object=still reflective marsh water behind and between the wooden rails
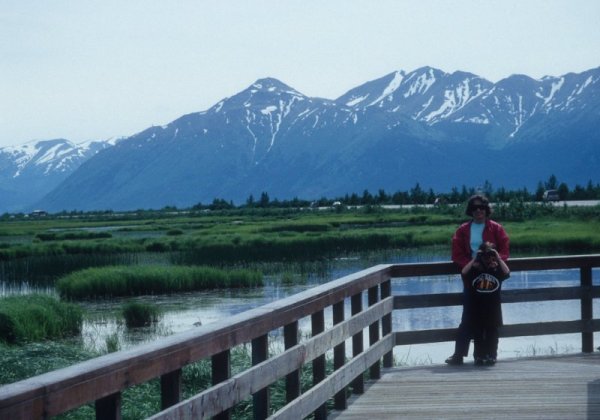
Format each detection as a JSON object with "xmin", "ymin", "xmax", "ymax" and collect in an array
[{"xmin": 0, "ymin": 249, "xmax": 600, "ymax": 365}]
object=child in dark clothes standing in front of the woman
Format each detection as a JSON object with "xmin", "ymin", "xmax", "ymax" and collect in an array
[{"xmin": 461, "ymin": 242, "xmax": 510, "ymax": 365}]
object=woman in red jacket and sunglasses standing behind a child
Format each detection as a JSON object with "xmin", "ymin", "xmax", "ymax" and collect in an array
[{"xmin": 446, "ymin": 194, "xmax": 509, "ymax": 365}]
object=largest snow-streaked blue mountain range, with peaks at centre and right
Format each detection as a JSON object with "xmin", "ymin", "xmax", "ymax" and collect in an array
[{"xmin": 2, "ymin": 67, "xmax": 600, "ymax": 211}]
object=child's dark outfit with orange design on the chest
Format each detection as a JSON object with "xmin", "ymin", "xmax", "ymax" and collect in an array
[{"xmin": 463, "ymin": 266, "xmax": 509, "ymax": 360}]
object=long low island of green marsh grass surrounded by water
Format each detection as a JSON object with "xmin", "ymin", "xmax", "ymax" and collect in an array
[{"xmin": 56, "ymin": 265, "xmax": 263, "ymax": 299}]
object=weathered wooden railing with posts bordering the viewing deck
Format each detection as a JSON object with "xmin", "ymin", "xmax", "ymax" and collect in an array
[{"xmin": 0, "ymin": 255, "xmax": 600, "ymax": 419}]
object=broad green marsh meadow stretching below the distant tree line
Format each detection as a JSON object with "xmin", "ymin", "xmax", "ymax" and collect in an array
[{"xmin": 0, "ymin": 205, "xmax": 600, "ymax": 282}]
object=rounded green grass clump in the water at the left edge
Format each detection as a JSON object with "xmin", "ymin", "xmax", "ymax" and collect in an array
[{"xmin": 0, "ymin": 294, "xmax": 83, "ymax": 344}]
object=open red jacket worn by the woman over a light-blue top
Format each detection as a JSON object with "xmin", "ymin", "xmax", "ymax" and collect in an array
[{"xmin": 452, "ymin": 219, "xmax": 509, "ymax": 270}]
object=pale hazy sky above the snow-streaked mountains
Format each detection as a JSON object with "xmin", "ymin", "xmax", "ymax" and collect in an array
[{"xmin": 0, "ymin": 0, "xmax": 600, "ymax": 147}]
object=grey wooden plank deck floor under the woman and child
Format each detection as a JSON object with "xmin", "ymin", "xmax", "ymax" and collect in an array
[{"xmin": 330, "ymin": 352, "xmax": 600, "ymax": 420}]
